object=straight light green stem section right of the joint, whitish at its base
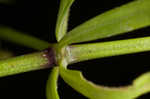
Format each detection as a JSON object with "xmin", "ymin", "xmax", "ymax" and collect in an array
[{"xmin": 66, "ymin": 37, "xmax": 150, "ymax": 63}]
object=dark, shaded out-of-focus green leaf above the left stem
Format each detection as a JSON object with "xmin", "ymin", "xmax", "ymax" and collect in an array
[{"xmin": 0, "ymin": 27, "xmax": 51, "ymax": 50}]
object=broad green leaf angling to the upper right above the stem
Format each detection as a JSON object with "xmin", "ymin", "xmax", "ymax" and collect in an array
[{"xmin": 60, "ymin": 0, "xmax": 150, "ymax": 46}]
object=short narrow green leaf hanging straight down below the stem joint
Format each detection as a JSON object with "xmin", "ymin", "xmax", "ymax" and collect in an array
[{"xmin": 46, "ymin": 67, "xmax": 59, "ymax": 99}]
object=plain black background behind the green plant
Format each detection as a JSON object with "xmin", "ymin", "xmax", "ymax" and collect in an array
[{"xmin": 0, "ymin": 0, "xmax": 150, "ymax": 99}]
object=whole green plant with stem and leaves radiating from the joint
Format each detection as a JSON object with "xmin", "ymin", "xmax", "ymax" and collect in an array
[{"xmin": 0, "ymin": 0, "xmax": 150, "ymax": 99}]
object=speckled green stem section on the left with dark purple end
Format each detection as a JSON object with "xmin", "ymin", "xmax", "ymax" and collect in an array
[{"xmin": 0, "ymin": 49, "xmax": 55, "ymax": 77}]
